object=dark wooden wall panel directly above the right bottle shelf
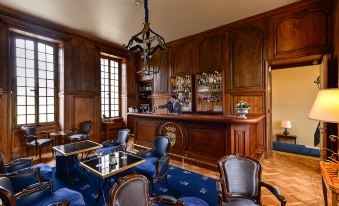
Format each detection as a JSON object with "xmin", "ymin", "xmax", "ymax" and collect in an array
[{"xmin": 196, "ymin": 32, "xmax": 225, "ymax": 72}]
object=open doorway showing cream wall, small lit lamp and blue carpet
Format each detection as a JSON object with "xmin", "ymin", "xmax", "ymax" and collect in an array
[{"xmin": 271, "ymin": 64, "xmax": 322, "ymax": 157}]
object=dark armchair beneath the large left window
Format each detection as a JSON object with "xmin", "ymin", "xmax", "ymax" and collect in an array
[{"xmin": 21, "ymin": 126, "xmax": 54, "ymax": 162}]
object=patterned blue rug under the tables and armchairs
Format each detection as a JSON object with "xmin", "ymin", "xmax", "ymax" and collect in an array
[{"xmin": 53, "ymin": 166, "xmax": 218, "ymax": 206}]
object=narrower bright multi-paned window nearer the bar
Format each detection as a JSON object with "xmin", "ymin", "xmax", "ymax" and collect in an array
[{"xmin": 101, "ymin": 57, "xmax": 120, "ymax": 117}]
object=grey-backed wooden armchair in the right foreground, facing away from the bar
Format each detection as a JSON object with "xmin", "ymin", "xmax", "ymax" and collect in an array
[{"xmin": 217, "ymin": 155, "xmax": 286, "ymax": 206}]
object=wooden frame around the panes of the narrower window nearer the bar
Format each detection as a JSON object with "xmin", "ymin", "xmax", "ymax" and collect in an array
[{"xmin": 99, "ymin": 54, "xmax": 122, "ymax": 119}]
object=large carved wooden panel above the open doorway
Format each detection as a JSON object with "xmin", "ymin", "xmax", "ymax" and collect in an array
[{"xmin": 270, "ymin": 1, "xmax": 332, "ymax": 60}]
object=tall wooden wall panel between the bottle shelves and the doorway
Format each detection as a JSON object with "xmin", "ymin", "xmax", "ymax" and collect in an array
[{"xmin": 226, "ymin": 23, "xmax": 267, "ymax": 90}]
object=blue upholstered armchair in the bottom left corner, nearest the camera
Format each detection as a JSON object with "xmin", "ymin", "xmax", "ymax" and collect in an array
[{"xmin": 0, "ymin": 177, "xmax": 86, "ymax": 206}]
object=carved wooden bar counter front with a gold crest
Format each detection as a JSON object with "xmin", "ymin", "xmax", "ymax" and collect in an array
[{"xmin": 127, "ymin": 113, "xmax": 266, "ymax": 166}]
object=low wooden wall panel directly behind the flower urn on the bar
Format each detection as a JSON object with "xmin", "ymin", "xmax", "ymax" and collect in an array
[{"xmin": 231, "ymin": 93, "xmax": 265, "ymax": 114}]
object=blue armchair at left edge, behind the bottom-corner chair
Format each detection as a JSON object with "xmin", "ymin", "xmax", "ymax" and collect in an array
[{"xmin": 0, "ymin": 152, "xmax": 53, "ymax": 181}]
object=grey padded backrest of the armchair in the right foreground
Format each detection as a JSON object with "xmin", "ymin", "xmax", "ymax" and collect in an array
[{"xmin": 219, "ymin": 155, "xmax": 261, "ymax": 204}]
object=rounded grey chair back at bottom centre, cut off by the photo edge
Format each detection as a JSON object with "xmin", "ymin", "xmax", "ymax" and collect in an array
[{"xmin": 108, "ymin": 174, "xmax": 150, "ymax": 206}]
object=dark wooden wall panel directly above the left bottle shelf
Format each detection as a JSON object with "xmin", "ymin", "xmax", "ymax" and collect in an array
[{"xmin": 171, "ymin": 41, "xmax": 195, "ymax": 75}]
